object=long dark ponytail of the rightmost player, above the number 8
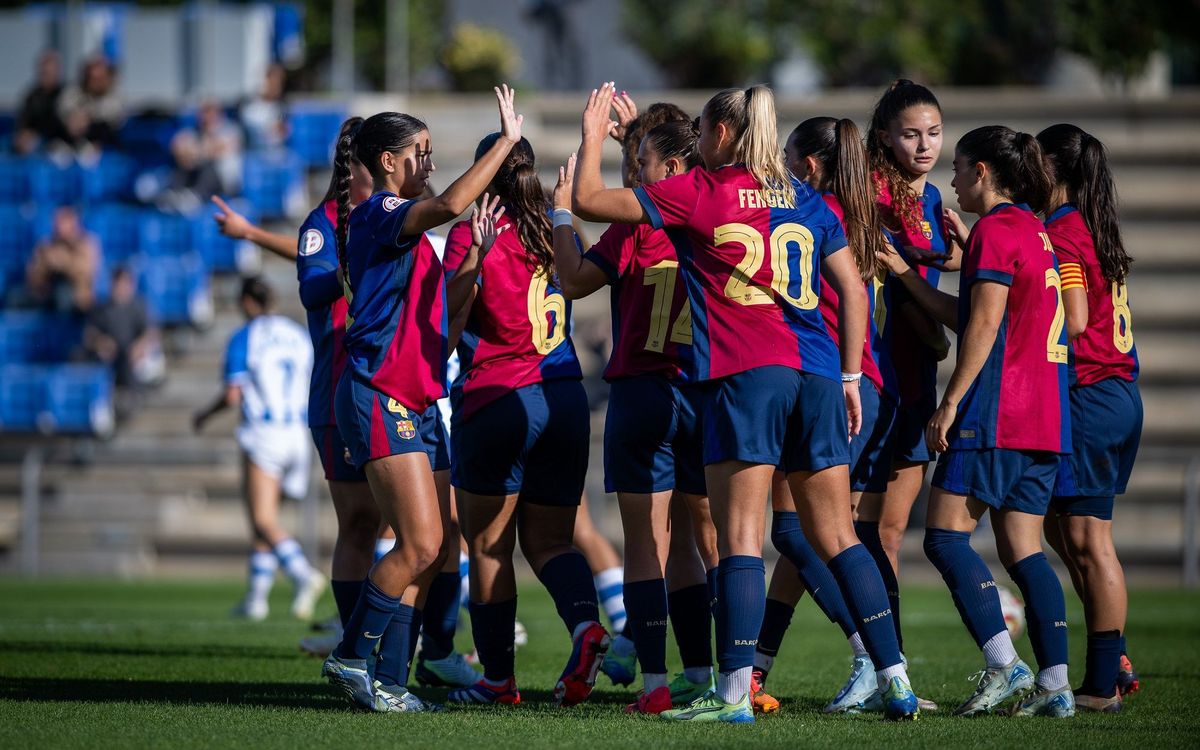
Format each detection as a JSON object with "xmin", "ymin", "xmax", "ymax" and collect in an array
[{"xmin": 1038, "ymin": 124, "xmax": 1133, "ymax": 283}]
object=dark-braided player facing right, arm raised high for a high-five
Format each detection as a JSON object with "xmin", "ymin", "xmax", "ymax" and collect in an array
[{"xmin": 323, "ymin": 85, "xmax": 523, "ymax": 712}]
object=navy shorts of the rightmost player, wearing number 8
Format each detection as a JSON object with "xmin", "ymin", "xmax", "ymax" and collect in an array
[{"xmin": 1054, "ymin": 378, "xmax": 1142, "ymax": 521}]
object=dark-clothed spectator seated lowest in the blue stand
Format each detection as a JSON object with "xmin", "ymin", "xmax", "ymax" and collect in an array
[{"xmin": 83, "ymin": 266, "xmax": 164, "ymax": 416}]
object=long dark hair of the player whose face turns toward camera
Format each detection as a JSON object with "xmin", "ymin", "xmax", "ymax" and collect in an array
[{"xmin": 866, "ymin": 78, "xmax": 942, "ymax": 230}]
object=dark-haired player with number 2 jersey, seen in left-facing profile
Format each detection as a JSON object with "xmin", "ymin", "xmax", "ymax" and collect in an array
[{"xmin": 884, "ymin": 125, "xmax": 1075, "ymax": 716}]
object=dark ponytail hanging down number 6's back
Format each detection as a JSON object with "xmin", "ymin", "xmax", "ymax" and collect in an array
[{"xmin": 475, "ymin": 133, "xmax": 554, "ymax": 278}]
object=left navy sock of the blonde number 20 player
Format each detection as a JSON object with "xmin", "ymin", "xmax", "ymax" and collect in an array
[{"xmin": 716, "ymin": 554, "xmax": 767, "ymax": 673}]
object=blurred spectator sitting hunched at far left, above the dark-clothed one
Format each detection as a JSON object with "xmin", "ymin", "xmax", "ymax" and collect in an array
[{"xmin": 25, "ymin": 205, "xmax": 101, "ymax": 313}]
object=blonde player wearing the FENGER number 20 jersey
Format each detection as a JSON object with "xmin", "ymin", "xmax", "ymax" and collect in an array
[{"xmin": 574, "ymin": 84, "xmax": 917, "ymax": 722}]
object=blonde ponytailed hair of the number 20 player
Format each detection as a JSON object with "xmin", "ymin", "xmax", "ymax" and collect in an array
[{"xmin": 703, "ymin": 85, "xmax": 796, "ymax": 208}]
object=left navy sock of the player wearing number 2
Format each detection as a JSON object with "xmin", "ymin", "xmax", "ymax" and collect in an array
[{"xmin": 924, "ymin": 528, "xmax": 1006, "ymax": 648}]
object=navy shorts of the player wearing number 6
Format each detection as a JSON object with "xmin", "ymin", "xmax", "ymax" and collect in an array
[{"xmin": 450, "ymin": 380, "xmax": 590, "ymax": 506}]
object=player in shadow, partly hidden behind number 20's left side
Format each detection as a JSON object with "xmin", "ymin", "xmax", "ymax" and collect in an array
[{"xmin": 554, "ymin": 120, "xmax": 712, "ymax": 714}]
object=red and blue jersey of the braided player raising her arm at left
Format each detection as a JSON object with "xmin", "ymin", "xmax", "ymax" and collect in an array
[{"xmin": 344, "ymin": 192, "xmax": 449, "ymax": 412}]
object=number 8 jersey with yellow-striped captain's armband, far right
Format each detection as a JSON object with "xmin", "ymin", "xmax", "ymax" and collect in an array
[{"xmin": 1046, "ymin": 203, "xmax": 1138, "ymax": 385}]
